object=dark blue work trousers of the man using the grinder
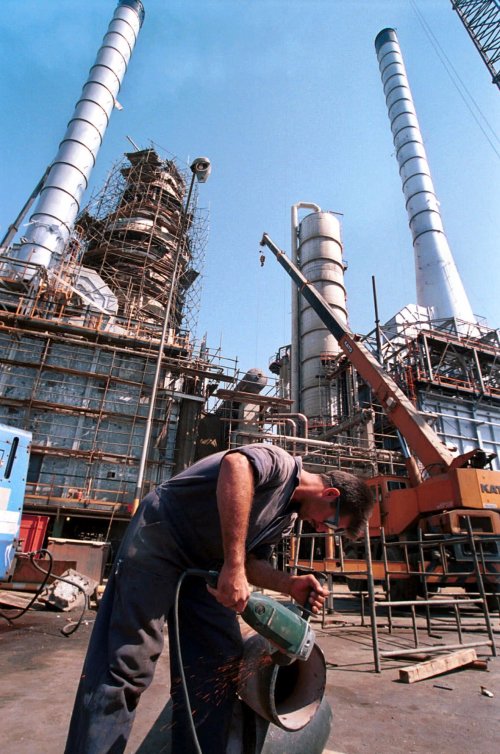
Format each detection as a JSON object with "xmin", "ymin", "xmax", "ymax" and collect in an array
[{"xmin": 65, "ymin": 493, "xmax": 242, "ymax": 754}]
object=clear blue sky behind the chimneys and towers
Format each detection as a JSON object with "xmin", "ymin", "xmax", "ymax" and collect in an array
[{"xmin": 0, "ymin": 0, "xmax": 500, "ymax": 376}]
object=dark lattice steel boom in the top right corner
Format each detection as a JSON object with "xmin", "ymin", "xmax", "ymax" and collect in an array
[{"xmin": 451, "ymin": 0, "xmax": 500, "ymax": 88}]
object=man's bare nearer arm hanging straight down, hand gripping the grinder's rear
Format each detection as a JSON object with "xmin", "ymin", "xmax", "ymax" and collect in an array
[{"xmin": 208, "ymin": 452, "xmax": 254, "ymax": 612}]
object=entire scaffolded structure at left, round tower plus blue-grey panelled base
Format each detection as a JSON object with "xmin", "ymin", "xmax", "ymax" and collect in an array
[{"xmin": 0, "ymin": 149, "xmax": 236, "ymax": 536}]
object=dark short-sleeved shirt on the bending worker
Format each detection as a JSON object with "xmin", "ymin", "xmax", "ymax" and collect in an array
[{"xmin": 157, "ymin": 444, "xmax": 302, "ymax": 567}]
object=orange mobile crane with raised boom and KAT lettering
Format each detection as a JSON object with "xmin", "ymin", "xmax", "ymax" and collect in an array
[{"xmin": 260, "ymin": 233, "xmax": 500, "ymax": 593}]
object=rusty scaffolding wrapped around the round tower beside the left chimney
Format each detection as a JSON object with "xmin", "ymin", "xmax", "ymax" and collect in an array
[{"xmin": 78, "ymin": 149, "xmax": 207, "ymax": 332}]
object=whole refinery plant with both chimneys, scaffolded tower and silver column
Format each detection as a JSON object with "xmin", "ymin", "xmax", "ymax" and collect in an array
[{"xmin": 0, "ymin": 0, "xmax": 500, "ymax": 568}]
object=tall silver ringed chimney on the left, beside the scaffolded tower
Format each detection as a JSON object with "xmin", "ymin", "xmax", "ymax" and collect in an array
[{"xmin": 12, "ymin": 0, "xmax": 144, "ymax": 280}]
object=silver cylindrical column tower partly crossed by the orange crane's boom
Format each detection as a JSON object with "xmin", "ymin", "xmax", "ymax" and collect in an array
[{"xmin": 292, "ymin": 209, "xmax": 347, "ymax": 423}]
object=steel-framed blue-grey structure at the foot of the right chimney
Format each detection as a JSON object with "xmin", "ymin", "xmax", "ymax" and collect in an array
[{"xmin": 376, "ymin": 320, "xmax": 500, "ymax": 469}]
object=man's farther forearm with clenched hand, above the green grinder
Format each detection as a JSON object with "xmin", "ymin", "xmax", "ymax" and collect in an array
[{"xmin": 246, "ymin": 555, "xmax": 327, "ymax": 613}]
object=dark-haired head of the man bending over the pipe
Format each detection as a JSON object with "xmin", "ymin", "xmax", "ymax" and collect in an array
[{"xmin": 320, "ymin": 471, "xmax": 373, "ymax": 539}]
